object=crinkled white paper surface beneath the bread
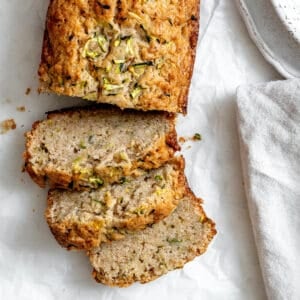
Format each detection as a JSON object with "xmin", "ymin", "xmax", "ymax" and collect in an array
[{"xmin": 0, "ymin": 0, "xmax": 280, "ymax": 300}]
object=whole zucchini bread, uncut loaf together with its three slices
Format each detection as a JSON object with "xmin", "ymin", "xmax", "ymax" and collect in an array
[{"xmin": 24, "ymin": 0, "xmax": 216, "ymax": 286}]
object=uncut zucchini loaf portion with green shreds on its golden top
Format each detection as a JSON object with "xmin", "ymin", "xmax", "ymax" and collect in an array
[{"xmin": 39, "ymin": 0, "xmax": 199, "ymax": 112}]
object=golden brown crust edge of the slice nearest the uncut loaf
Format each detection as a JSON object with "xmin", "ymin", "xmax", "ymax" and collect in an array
[{"xmin": 23, "ymin": 105, "xmax": 180, "ymax": 190}]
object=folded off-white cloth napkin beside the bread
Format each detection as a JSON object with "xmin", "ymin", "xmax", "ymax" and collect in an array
[{"xmin": 237, "ymin": 79, "xmax": 300, "ymax": 300}]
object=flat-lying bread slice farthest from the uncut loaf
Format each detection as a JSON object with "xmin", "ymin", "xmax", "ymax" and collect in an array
[{"xmin": 89, "ymin": 193, "xmax": 216, "ymax": 287}]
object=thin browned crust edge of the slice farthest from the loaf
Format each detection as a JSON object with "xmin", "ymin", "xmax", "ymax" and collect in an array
[{"xmin": 92, "ymin": 187, "xmax": 217, "ymax": 287}]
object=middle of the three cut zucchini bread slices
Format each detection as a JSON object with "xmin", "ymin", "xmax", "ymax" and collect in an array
[{"xmin": 45, "ymin": 157, "xmax": 186, "ymax": 249}]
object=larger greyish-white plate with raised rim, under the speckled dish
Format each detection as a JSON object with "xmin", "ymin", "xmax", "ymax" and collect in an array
[{"xmin": 236, "ymin": 0, "xmax": 300, "ymax": 78}]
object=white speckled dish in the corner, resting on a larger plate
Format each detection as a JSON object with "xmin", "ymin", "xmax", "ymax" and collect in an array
[{"xmin": 271, "ymin": 0, "xmax": 300, "ymax": 43}]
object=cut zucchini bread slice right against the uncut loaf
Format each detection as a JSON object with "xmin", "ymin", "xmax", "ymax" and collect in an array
[{"xmin": 24, "ymin": 107, "xmax": 179, "ymax": 190}]
